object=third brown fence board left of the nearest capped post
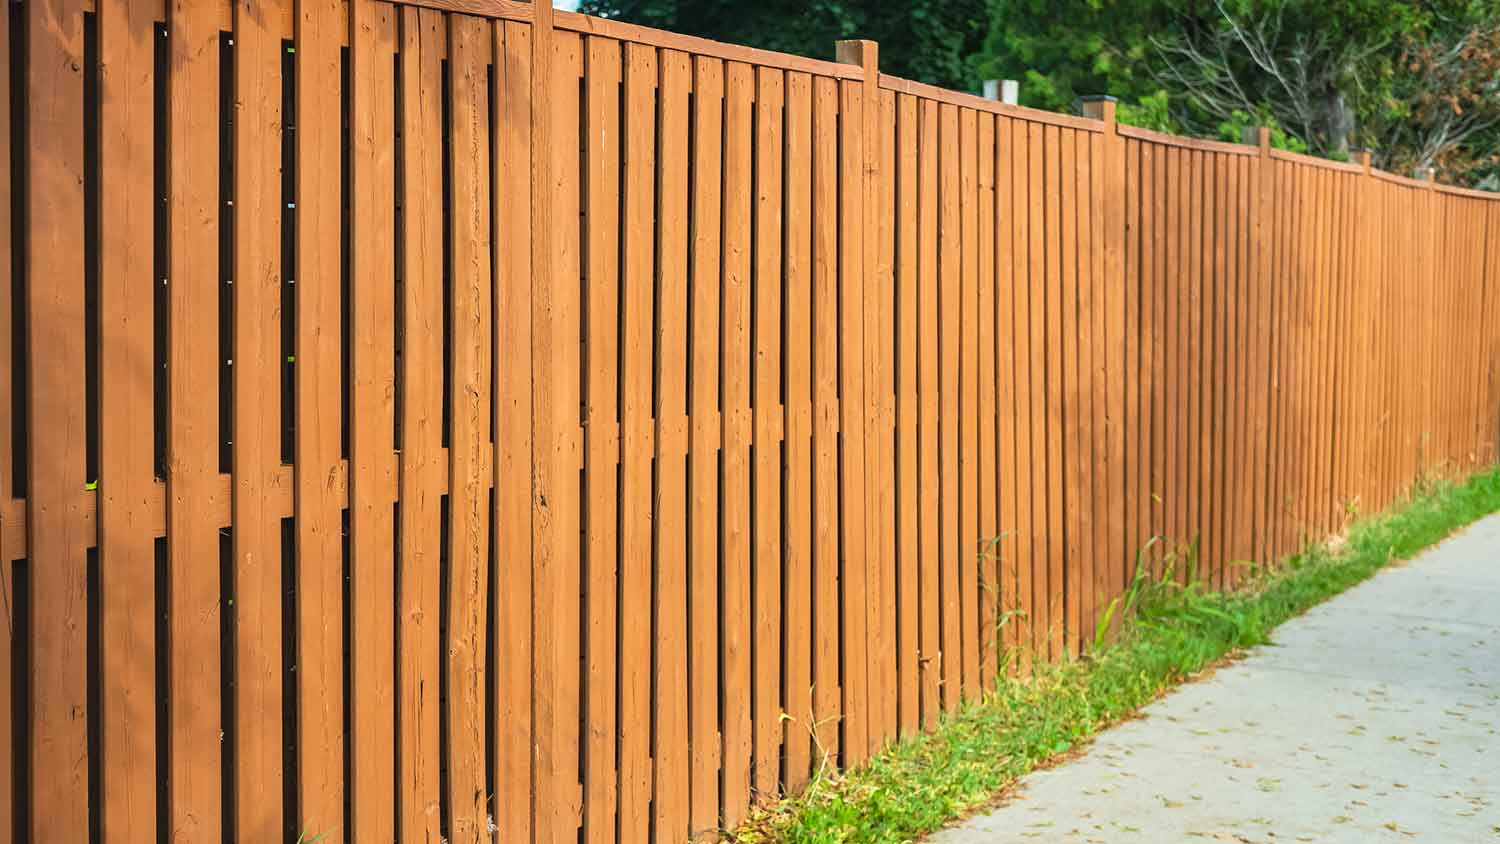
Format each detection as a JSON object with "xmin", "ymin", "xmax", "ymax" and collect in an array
[{"xmin": 750, "ymin": 67, "xmax": 786, "ymax": 796}]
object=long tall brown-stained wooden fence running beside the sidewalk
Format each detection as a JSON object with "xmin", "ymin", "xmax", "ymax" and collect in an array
[{"xmin": 0, "ymin": 0, "xmax": 1500, "ymax": 844}]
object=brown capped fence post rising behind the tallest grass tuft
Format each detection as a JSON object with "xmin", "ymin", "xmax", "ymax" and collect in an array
[{"xmin": 1083, "ymin": 96, "xmax": 1139, "ymax": 636}]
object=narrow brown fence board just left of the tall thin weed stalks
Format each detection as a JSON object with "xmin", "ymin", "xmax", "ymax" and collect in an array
[{"xmin": 954, "ymin": 109, "xmax": 983, "ymax": 686}]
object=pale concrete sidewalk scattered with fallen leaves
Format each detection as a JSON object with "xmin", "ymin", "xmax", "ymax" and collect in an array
[{"xmin": 932, "ymin": 516, "xmax": 1500, "ymax": 844}]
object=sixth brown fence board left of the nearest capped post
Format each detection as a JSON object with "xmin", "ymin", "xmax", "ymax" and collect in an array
[{"xmin": 653, "ymin": 51, "xmax": 692, "ymax": 840}]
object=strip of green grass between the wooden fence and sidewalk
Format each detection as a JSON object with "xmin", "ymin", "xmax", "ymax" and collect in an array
[{"xmin": 731, "ymin": 469, "xmax": 1500, "ymax": 844}]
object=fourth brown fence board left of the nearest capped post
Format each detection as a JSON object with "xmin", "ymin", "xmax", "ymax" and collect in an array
[{"xmin": 719, "ymin": 63, "xmax": 755, "ymax": 829}]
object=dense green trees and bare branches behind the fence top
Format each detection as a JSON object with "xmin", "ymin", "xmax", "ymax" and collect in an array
[{"xmin": 582, "ymin": 0, "xmax": 1500, "ymax": 189}]
